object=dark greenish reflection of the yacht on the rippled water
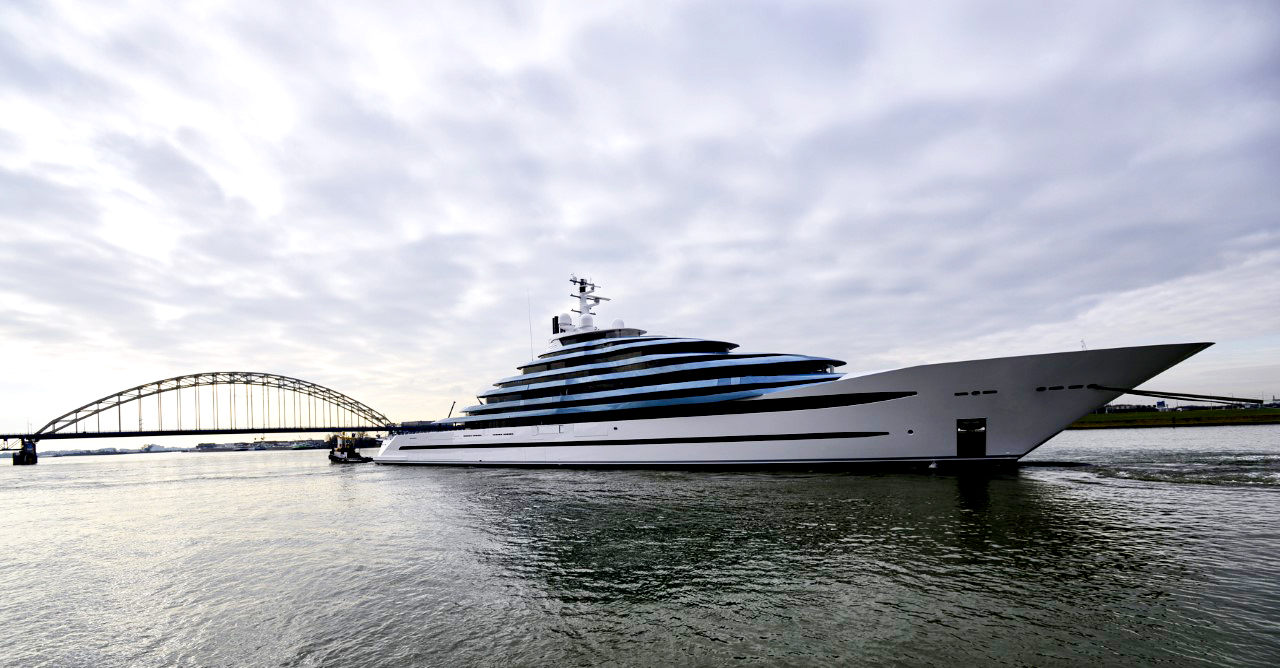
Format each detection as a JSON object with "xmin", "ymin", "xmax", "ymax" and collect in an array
[{"xmin": 391, "ymin": 470, "xmax": 1249, "ymax": 664}]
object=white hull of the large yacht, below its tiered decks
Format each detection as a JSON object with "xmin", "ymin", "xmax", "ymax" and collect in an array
[{"xmin": 374, "ymin": 343, "xmax": 1210, "ymax": 467}]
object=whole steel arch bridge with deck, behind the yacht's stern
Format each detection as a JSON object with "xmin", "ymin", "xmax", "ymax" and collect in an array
[{"xmin": 0, "ymin": 371, "xmax": 396, "ymax": 449}]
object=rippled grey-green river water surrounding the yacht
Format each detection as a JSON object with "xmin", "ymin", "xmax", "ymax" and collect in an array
[{"xmin": 0, "ymin": 426, "xmax": 1280, "ymax": 667}]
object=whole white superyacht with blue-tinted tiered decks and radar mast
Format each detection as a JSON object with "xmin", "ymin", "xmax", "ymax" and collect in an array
[{"xmin": 374, "ymin": 276, "xmax": 1211, "ymax": 467}]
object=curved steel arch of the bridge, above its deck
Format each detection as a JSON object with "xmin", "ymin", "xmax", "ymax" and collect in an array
[{"xmin": 32, "ymin": 371, "xmax": 392, "ymax": 438}]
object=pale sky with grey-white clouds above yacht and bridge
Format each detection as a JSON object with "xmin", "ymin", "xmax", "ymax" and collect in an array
[{"xmin": 0, "ymin": 0, "xmax": 1280, "ymax": 442}]
